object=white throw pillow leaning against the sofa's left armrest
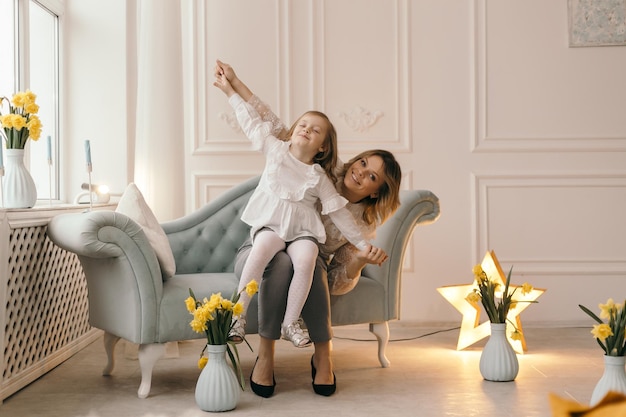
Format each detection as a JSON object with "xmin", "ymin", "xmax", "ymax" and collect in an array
[{"xmin": 115, "ymin": 183, "xmax": 176, "ymax": 279}]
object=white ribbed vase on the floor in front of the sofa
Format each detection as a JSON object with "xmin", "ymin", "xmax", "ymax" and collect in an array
[{"xmin": 196, "ymin": 345, "xmax": 241, "ymax": 411}]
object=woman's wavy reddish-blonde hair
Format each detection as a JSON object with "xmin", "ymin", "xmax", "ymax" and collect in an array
[{"xmin": 341, "ymin": 149, "xmax": 402, "ymax": 224}]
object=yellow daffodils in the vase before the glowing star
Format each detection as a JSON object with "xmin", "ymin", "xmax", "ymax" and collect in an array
[{"xmin": 466, "ymin": 265, "xmax": 536, "ymax": 340}]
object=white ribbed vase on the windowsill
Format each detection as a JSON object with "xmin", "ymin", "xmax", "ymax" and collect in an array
[{"xmin": 0, "ymin": 149, "xmax": 37, "ymax": 208}]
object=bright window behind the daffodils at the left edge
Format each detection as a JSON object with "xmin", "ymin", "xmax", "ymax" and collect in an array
[{"xmin": 0, "ymin": 0, "xmax": 60, "ymax": 200}]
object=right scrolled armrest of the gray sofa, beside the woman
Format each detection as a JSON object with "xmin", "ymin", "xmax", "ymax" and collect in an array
[{"xmin": 362, "ymin": 190, "xmax": 440, "ymax": 319}]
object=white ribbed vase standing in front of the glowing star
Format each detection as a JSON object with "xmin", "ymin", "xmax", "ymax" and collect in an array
[{"xmin": 479, "ymin": 323, "xmax": 519, "ymax": 382}]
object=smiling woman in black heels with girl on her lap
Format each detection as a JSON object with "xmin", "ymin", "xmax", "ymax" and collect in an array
[{"xmin": 215, "ymin": 61, "xmax": 401, "ymax": 398}]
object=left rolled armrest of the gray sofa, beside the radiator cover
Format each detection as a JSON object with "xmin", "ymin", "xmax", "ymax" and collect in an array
[{"xmin": 47, "ymin": 210, "xmax": 163, "ymax": 343}]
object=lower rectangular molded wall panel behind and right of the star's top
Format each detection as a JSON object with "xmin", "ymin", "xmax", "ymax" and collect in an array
[{"xmin": 472, "ymin": 172, "xmax": 626, "ymax": 276}]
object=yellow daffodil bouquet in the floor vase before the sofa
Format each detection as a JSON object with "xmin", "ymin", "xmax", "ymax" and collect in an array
[{"xmin": 185, "ymin": 280, "xmax": 259, "ymax": 389}]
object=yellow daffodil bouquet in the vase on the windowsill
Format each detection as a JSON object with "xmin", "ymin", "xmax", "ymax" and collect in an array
[{"xmin": 0, "ymin": 90, "xmax": 41, "ymax": 149}]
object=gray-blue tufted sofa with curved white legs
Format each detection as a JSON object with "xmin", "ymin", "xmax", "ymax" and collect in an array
[{"xmin": 48, "ymin": 177, "xmax": 439, "ymax": 398}]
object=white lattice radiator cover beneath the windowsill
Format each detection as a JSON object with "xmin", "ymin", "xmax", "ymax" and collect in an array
[{"xmin": 0, "ymin": 206, "xmax": 112, "ymax": 402}]
